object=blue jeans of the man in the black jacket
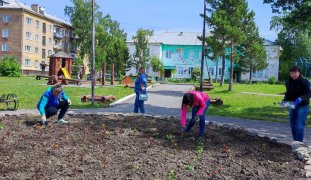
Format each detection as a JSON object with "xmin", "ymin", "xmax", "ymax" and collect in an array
[{"xmin": 288, "ymin": 105, "xmax": 309, "ymax": 142}]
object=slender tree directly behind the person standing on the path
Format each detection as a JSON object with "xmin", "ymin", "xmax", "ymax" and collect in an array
[{"xmin": 128, "ymin": 29, "xmax": 153, "ymax": 68}]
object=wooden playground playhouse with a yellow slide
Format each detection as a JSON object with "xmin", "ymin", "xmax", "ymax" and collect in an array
[{"xmin": 36, "ymin": 52, "xmax": 83, "ymax": 85}]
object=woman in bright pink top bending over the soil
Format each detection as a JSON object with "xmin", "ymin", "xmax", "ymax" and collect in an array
[{"xmin": 180, "ymin": 91, "xmax": 210, "ymax": 137}]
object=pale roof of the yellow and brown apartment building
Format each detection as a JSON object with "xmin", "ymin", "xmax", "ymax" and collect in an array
[{"xmin": 0, "ymin": 0, "xmax": 71, "ymax": 26}]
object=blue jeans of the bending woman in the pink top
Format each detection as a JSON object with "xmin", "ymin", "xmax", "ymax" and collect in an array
[{"xmin": 185, "ymin": 100, "xmax": 210, "ymax": 137}]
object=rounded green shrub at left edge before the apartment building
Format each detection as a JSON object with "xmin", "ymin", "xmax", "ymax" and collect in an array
[{"xmin": 0, "ymin": 56, "xmax": 21, "ymax": 77}]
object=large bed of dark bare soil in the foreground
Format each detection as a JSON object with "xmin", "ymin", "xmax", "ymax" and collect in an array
[{"xmin": 0, "ymin": 114, "xmax": 305, "ymax": 180}]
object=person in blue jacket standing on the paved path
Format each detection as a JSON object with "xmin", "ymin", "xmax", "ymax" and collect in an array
[{"xmin": 134, "ymin": 67, "xmax": 147, "ymax": 113}]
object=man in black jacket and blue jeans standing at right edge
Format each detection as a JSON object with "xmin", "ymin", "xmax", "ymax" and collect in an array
[{"xmin": 283, "ymin": 66, "xmax": 311, "ymax": 142}]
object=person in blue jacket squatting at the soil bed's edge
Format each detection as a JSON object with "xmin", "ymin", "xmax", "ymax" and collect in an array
[{"xmin": 37, "ymin": 83, "xmax": 71, "ymax": 125}]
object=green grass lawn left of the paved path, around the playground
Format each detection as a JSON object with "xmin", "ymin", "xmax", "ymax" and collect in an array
[{"xmin": 0, "ymin": 76, "xmax": 133, "ymax": 109}]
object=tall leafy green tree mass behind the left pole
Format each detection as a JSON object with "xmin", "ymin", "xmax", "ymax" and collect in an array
[{"xmin": 65, "ymin": 0, "xmax": 129, "ymax": 74}]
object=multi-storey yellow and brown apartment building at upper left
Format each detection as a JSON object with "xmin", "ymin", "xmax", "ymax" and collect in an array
[{"xmin": 0, "ymin": 0, "xmax": 74, "ymax": 74}]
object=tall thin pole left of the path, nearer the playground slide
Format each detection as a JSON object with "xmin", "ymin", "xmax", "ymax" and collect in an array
[{"xmin": 91, "ymin": 0, "xmax": 96, "ymax": 104}]
